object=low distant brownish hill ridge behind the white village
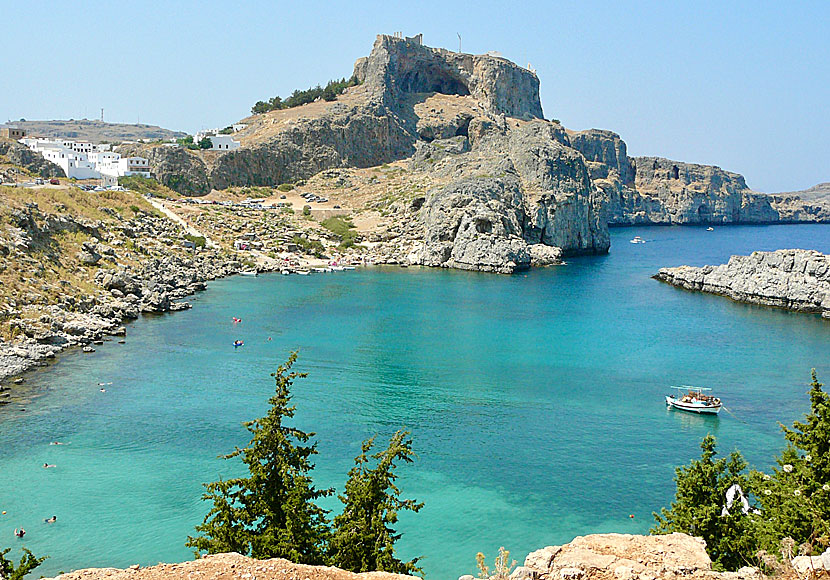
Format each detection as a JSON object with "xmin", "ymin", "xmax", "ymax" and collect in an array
[{"xmin": 4, "ymin": 119, "xmax": 187, "ymax": 143}]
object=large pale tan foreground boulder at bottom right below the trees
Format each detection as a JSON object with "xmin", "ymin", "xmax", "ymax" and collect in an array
[{"xmin": 510, "ymin": 533, "xmax": 760, "ymax": 580}]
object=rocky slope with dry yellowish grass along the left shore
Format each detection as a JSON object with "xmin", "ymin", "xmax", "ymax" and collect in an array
[{"xmin": 0, "ymin": 198, "xmax": 254, "ymax": 390}]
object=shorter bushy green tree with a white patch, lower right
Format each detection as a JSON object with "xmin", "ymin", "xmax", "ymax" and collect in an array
[{"xmin": 651, "ymin": 435, "xmax": 757, "ymax": 570}]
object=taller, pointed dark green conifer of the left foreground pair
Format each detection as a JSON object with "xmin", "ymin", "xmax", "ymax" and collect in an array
[{"xmin": 187, "ymin": 352, "xmax": 333, "ymax": 564}]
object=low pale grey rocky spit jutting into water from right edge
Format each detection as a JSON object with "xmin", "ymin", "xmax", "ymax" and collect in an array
[{"xmin": 654, "ymin": 250, "xmax": 830, "ymax": 319}]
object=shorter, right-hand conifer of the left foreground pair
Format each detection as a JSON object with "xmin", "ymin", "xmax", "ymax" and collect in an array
[{"xmin": 330, "ymin": 431, "xmax": 424, "ymax": 574}]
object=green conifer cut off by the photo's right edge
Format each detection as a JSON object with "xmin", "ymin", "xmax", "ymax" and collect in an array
[{"xmin": 752, "ymin": 369, "xmax": 830, "ymax": 552}]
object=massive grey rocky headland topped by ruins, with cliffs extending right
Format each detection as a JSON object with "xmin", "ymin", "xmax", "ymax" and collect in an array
[{"xmin": 75, "ymin": 35, "xmax": 830, "ymax": 272}]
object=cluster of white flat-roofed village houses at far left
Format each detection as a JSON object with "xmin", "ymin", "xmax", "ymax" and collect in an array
[{"xmin": 20, "ymin": 137, "xmax": 150, "ymax": 185}]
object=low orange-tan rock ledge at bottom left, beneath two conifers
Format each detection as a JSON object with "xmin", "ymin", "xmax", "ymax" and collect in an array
[{"xmin": 44, "ymin": 553, "xmax": 414, "ymax": 580}]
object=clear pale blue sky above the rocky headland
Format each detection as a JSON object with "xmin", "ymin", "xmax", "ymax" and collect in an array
[{"xmin": 0, "ymin": 0, "xmax": 830, "ymax": 192}]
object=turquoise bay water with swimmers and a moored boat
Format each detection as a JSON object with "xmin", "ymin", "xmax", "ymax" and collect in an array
[{"xmin": 0, "ymin": 226, "xmax": 830, "ymax": 578}]
